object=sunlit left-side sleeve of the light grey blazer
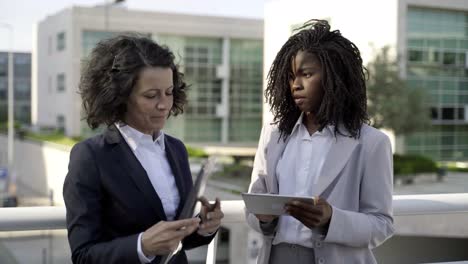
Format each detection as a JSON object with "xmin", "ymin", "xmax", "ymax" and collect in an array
[{"xmin": 244, "ymin": 125, "xmax": 278, "ymax": 236}]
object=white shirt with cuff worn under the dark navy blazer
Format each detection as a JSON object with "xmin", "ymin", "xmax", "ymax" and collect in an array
[{"xmin": 116, "ymin": 124, "xmax": 180, "ymax": 263}]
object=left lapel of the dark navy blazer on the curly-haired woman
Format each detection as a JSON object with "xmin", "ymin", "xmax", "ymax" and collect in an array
[{"xmin": 105, "ymin": 126, "xmax": 167, "ymax": 220}]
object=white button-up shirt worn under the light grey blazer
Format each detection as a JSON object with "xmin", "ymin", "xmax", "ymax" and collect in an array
[{"xmin": 273, "ymin": 113, "xmax": 334, "ymax": 248}]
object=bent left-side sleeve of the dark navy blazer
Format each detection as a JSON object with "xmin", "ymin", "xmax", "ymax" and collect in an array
[{"xmin": 63, "ymin": 141, "xmax": 139, "ymax": 264}]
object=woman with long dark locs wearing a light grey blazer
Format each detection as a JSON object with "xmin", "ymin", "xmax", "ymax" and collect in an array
[{"xmin": 246, "ymin": 20, "xmax": 394, "ymax": 264}]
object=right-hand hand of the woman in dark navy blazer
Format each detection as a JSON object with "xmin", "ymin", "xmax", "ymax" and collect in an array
[{"xmin": 197, "ymin": 196, "xmax": 224, "ymax": 236}]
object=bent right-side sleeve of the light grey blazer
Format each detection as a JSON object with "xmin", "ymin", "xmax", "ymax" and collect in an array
[{"xmin": 325, "ymin": 134, "xmax": 394, "ymax": 248}]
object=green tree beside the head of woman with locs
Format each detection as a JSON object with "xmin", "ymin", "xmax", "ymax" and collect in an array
[{"xmin": 367, "ymin": 47, "xmax": 430, "ymax": 135}]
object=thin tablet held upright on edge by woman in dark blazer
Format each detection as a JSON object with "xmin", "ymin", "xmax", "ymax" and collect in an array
[{"xmin": 160, "ymin": 157, "xmax": 216, "ymax": 264}]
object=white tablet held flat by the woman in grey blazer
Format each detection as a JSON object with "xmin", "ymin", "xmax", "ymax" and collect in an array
[{"xmin": 242, "ymin": 193, "xmax": 317, "ymax": 215}]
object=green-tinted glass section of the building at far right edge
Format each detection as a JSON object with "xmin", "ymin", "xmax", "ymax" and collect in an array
[{"xmin": 405, "ymin": 7, "xmax": 468, "ymax": 161}]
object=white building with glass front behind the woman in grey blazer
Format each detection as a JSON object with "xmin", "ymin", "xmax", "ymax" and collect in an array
[{"xmin": 263, "ymin": 0, "xmax": 468, "ymax": 161}]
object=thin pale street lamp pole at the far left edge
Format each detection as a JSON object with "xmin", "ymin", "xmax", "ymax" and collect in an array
[{"xmin": 0, "ymin": 22, "xmax": 16, "ymax": 199}]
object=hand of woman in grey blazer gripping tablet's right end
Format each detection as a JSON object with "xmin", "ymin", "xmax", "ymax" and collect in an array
[{"xmin": 286, "ymin": 198, "xmax": 332, "ymax": 229}]
